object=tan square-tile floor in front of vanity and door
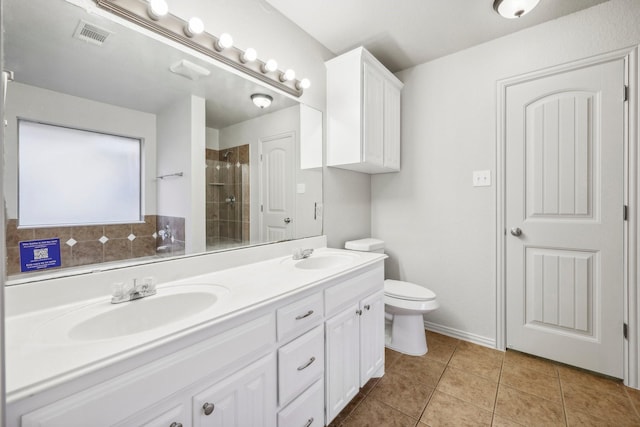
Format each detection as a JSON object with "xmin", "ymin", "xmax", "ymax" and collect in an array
[{"xmin": 330, "ymin": 332, "xmax": 640, "ymax": 427}]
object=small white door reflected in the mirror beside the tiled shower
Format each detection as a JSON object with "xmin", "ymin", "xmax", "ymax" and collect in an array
[{"xmin": 260, "ymin": 133, "xmax": 296, "ymax": 242}]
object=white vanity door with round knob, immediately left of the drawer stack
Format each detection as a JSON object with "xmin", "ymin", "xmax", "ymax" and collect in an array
[{"xmin": 193, "ymin": 354, "xmax": 276, "ymax": 427}]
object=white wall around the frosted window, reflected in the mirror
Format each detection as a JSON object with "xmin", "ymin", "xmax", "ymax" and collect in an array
[{"xmin": 4, "ymin": 82, "xmax": 156, "ymax": 218}]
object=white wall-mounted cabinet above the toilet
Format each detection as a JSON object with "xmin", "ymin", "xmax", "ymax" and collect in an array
[{"xmin": 326, "ymin": 47, "xmax": 403, "ymax": 173}]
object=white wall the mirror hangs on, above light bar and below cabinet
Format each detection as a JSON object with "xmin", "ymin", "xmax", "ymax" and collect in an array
[{"xmin": 162, "ymin": 0, "xmax": 371, "ymax": 251}]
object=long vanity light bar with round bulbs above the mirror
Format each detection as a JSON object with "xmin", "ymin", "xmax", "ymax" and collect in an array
[{"xmin": 95, "ymin": 0, "xmax": 309, "ymax": 97}]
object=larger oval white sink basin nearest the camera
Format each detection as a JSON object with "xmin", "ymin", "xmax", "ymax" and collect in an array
[{"xmin": 35, "ymin": 284, "xmax": 229, "ymax": 341}]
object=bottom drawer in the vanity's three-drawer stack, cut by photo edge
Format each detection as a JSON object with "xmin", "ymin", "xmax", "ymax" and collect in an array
[{"xmin": 278, "ymin": 380, "xmax": 324, "ymax": 427}]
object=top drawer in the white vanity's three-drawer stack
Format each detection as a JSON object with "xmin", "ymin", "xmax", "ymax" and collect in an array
[{"xmin": 276, "ymin": 292, "xmax": 323, "ymax": 341}]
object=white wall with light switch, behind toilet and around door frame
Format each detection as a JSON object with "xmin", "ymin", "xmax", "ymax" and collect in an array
[{"xmin": 371, "ymin": 0, "xmax": 640, "ymax": 344}]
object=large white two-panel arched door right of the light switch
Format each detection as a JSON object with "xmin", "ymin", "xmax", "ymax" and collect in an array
[{"xmin": 505, "ymin": 59, "xmax": 625, "ymax": 378}]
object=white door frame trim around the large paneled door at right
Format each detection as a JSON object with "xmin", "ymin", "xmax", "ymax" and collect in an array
[{"xmin": 495, "ymin": 46, "xmax": 640, "ymax": 388}]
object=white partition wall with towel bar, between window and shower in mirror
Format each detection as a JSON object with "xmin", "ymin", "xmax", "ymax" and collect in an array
[{"xmin": 157, "ymin": 96, "xmax": 206, "ymax": 253}]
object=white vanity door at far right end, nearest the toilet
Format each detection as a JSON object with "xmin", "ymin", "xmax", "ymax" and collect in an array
[{"xmin": 360, "ymin": 291, "xmax": 384, "ymax": 387}]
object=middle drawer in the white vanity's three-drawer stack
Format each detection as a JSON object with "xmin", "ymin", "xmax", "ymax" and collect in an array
[{"xmin": 278, "ymin": 325, "xmax": 324, "ymax": 406}]
